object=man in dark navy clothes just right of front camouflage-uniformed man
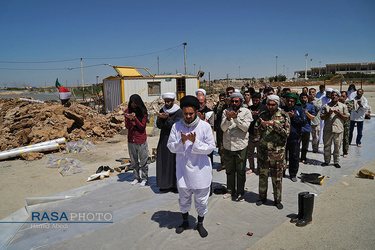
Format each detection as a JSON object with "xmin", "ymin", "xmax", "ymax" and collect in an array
[{"xmin": 281, "ymin": 93, "xmax": 306, "ymax": 182}]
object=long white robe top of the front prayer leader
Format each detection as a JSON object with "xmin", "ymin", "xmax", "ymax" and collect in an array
[{"xmin": 167, "ymin": 121, "xmax": 216, "ymax": 189}]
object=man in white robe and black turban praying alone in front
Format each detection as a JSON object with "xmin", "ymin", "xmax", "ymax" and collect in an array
[{"xmin": 167, "ymin": 96, "xmax": 216, "ymax": 237}]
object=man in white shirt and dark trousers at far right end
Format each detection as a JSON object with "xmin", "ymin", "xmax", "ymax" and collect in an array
[{"xmin": 349, "ymin": 89, "xmax": 368, "ymax": 147}]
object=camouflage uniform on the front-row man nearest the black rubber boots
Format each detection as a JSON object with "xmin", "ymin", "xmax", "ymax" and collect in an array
[{"xmin": 255, "ymin": 110, "xmax": 290, "ymax": 203}]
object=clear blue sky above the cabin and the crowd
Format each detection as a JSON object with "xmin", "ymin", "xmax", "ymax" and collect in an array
[{"xmin": 0, "ymin": 0, "xmax": 375, "ymax": 87}]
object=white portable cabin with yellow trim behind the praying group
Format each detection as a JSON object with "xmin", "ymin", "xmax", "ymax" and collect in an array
[{"xmin": 103, "ymin": 66, "xmax": 203, "ymax": 112}]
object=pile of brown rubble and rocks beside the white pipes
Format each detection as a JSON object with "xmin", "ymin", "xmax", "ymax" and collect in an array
[{"xmin": 0, "ymin": 98, "xmax": 122, "ymax": 151}]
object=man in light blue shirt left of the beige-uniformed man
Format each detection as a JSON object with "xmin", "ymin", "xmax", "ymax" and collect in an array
[{"xmin": 299, "ymin": 92, "xmax": 316, "ymax": 164}]
